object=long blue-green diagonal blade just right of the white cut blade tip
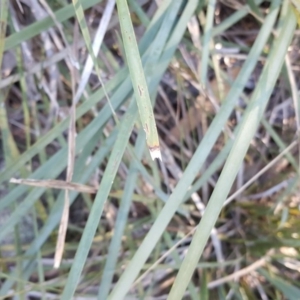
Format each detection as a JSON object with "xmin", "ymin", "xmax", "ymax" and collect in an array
[{"xmin": 109, "ymin": 1, "xmax": 282, "ymax": 300}]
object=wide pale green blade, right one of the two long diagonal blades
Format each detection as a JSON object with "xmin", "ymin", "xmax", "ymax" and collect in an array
[{"xmin": 168, "ymin": 2, "xmax": 296, "ymax": 300}]
